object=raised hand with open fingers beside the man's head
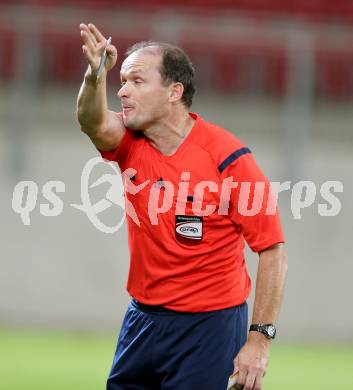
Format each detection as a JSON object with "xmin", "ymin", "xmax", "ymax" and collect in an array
[{"xmin": 80, "ymin": 23, "xmax": 118, "ymax": 77}]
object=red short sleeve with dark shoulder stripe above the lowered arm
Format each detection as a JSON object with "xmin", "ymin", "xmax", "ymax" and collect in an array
[{"xmin": 222, "ymin": 148, "xmax": 284, "ymax": 252}]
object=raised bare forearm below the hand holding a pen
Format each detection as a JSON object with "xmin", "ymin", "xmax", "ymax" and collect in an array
[{"xmin": 77, "ymin": 69, "xmax": 108, "ymax": 134}]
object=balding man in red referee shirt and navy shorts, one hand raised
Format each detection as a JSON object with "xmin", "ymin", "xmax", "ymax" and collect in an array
[{"xmin": 77, "ymin": 24, "xmax": 287, "ymax": 390}]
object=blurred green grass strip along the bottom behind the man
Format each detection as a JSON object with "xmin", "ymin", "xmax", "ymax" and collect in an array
[{"xmin": 0, "ymin": 329, "xmax": 353, "ymax": 390}]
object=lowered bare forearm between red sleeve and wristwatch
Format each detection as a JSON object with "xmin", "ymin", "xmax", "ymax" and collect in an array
[{"xmin": 250, "ymin": 244, "xmax": 288, "ymax": 333}]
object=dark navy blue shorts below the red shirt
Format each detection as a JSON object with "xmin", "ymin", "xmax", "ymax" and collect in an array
[{"xmin": 107, "ymin": 300, "xmax": 248, "ymax": 390}]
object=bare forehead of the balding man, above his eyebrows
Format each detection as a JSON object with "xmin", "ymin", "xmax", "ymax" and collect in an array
[{"xmin": 120, "ymin": 50, "xmax": 161, "ymax": 76}]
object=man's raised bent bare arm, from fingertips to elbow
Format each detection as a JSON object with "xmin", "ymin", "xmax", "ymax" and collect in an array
[{"xmin": 77, "ymin": 24, "xmax": 126, "ymax": 151}]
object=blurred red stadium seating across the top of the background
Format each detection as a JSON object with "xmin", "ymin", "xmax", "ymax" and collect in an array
[{"xmin": 0, "ymin": 0, "xmax": 353, "ymax": 98}]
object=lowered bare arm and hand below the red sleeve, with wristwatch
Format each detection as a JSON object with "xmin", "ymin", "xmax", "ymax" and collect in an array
[{"xmin": 234, "ymin": 244, "xmax": 288, "ymax": 390}]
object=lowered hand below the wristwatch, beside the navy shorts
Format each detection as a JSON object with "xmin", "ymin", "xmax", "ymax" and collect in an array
[{"xmin": 234, "ymin": 332, "xmax": 270, "ymax": 390}]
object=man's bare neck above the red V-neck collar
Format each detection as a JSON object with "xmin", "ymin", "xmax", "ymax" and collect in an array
[{"xmin": 144, "ymin": 110, "xmax": 195, "ymax": 156}]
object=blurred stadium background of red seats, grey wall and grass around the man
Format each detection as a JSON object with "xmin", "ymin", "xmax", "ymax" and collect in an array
[{"xmin": 0, "ymin": 0, "xmax": 353, "ymax": 390}]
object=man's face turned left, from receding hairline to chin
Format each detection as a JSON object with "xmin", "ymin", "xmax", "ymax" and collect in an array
[{"xmin": 118, "ymin": 50, "xmax": 170, "ymax": 130}]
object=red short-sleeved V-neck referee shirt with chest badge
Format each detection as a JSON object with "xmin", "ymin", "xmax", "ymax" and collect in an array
[{"xmin": 101, "ymin": 113, "xmax": 284, "ymax": 312}]
